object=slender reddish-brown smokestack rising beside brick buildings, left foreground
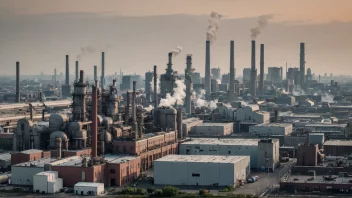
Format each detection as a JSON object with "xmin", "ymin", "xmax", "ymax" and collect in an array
[{"xmin": 91, "ymin": 86, "xmax": 98, "ymax": 157}]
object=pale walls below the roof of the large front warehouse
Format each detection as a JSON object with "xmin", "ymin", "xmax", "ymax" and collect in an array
[{"xmin": 154, "ymin": 157, "xmax": 250, "ymax": 186}]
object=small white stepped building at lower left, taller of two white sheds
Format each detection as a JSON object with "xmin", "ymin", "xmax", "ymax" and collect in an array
[{"xmin": 33, "ymin": 171, "xmax": 63, "ymax": 194}]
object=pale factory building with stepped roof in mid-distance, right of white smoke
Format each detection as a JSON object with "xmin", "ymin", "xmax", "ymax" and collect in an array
[{"xmin": 236, "ymin": 105, "xmax": 270, "ymax": 124}]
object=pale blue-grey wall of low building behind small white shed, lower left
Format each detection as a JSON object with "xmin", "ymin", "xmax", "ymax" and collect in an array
[{"xmin": 11, "ymin": 166, "xmax": 44, "ymax": 186}]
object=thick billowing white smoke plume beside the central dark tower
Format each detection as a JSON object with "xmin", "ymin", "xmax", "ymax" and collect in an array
[{"xmin": 159, "ymin": 80, "xmax": 186, "ymax": 107}]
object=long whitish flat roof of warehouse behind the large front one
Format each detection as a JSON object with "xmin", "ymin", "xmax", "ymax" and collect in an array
[{"xmin": 182, "ymin": 138, "xmax": 259, "ymax": 146}]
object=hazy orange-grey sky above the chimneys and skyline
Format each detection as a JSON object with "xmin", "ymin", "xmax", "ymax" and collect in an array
[{"xmin": 0, "ymin": 0, "xmax": 352, "ymax": 75}]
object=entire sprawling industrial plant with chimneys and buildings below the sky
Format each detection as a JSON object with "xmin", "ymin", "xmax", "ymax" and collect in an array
[{"xmin": 0, "ymin": 5, "xmax": 352, "ymax": 197}]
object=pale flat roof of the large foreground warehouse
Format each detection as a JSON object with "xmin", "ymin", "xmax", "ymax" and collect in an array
[{"xmin": 155, "ymin": 155, "xmax": 249, "ymax": 164}]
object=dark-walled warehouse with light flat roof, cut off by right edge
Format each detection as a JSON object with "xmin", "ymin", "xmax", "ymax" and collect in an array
[{"xmin": 324, "ymin": 140, "xmax": 352, "ymax": 156}]
